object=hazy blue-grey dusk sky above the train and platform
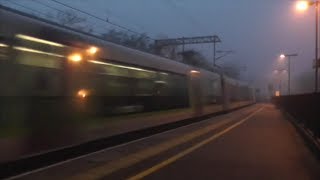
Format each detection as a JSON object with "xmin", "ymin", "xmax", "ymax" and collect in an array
[{"xmin": 0, "ymin": 0, "xmax": 315, "ymax": 94}]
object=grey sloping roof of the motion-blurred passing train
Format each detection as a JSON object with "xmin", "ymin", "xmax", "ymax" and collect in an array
[{"xmin": 0, "ymin": 5, "xmax": 250, "ymax": 85}]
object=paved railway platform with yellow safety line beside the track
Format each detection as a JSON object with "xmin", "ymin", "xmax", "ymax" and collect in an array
[{"xmin": 16, "ymin": 104, "xmax": 320, "ymax": 179}]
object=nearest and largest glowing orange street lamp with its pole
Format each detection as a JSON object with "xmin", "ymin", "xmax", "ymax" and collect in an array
[{"xmin": 296, "ymin": 0, "xmax": 320, "ymax": 92}]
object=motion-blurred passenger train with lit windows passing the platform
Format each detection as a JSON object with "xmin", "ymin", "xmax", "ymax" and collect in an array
[{"xmin": 0, "ymin": 6, "xmax": 255, "ymax": 163}]
